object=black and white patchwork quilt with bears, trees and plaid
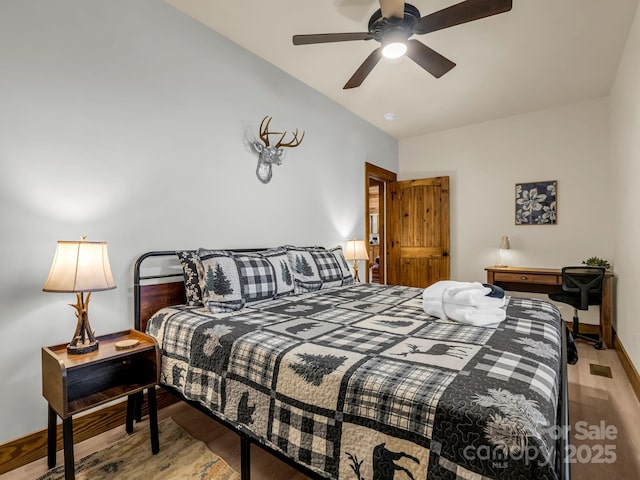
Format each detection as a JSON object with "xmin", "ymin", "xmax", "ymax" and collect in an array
[{"xmin": 147, "ymin": 284, "xmax": 562, "ymax": 480}]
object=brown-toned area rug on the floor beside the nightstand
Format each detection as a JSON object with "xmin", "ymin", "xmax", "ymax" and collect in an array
[{"xmin": 38, "ymin": 418, "xmax": 240, "ymax": 480}]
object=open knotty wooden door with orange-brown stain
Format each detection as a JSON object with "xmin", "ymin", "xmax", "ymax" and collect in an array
[{"xmin": 387, "ymin": 177, "xmax": 450, "ymax": 288}]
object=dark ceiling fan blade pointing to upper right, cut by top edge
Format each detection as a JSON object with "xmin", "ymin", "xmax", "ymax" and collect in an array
[{"xmin": 413, "ymin": 0, "xmax": 513, "ymax": 35}]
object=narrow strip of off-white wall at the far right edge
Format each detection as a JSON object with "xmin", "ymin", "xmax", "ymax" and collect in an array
[{"xmin": 611, "ymin": 1, "xmax": 640, "ymax": 370}]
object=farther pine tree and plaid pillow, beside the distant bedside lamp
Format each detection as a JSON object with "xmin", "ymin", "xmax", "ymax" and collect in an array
[{"xmin": 285, "ymin": 245, "xmax": 343, "ymax": 293}]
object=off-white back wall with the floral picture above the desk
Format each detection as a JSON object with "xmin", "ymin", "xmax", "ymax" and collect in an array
[{"xmin": 398, "ymin": 98, "xmax": 614, "ymax": 323}]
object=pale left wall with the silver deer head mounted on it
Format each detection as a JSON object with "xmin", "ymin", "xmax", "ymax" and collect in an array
[{"xmin": 0, "ymin": 0, "xmax": 398, "ymax": 443}]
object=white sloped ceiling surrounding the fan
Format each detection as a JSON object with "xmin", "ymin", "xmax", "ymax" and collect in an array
[{"xmin": 166, "ymin": 0, "xmax": 638, "ymax": 138}]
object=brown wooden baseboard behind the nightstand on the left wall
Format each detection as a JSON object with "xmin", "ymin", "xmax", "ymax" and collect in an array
[{"xmin": 0, "ymin": 389, "xmax": 177, "ymax": 475}]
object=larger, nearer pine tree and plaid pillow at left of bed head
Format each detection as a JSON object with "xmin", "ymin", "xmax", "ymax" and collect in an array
[{"xmin": 198, "ymin": 248, "xmax": 293, "ymax": 313}]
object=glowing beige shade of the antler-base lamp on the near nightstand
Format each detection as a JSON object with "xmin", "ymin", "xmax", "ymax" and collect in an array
[{"xmin": 42, "ymin": 240, "xmax": 116, "ymax": 292}]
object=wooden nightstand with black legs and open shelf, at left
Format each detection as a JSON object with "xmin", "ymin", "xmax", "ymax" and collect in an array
[{"xmin": 42, "ymin": 330, "xmax": 160, "ymax": 480}]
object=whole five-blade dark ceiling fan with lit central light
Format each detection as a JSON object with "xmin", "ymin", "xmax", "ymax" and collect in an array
[{"xmin": 293, "ymin": 0, "xmax": 512, "ymax": 89}]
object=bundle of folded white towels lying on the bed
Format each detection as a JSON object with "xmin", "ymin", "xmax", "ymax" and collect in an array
[{"xmin": 422, "ymin": 280, "xmax": 507, "ymax": 328}]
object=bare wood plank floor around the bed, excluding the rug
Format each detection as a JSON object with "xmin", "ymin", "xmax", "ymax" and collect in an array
[{"xmin": 0, "ymin": 343, "xmax": 640, "ymax": 480}]
